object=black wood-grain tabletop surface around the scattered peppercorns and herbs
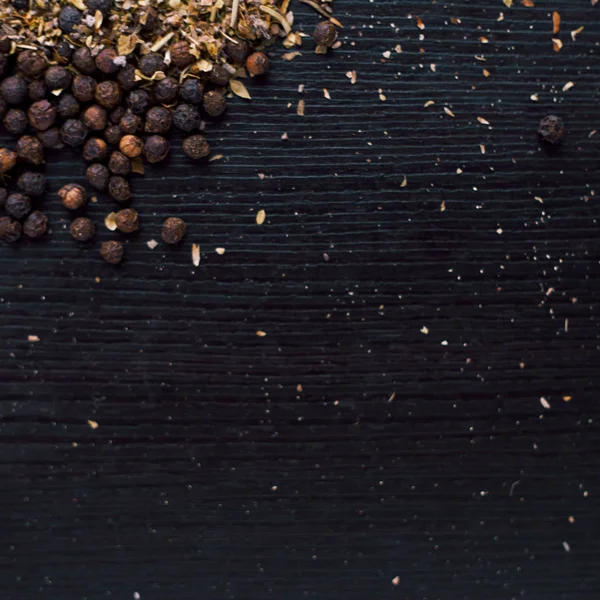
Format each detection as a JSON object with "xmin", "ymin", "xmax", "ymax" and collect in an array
[{"xmin": 0, "ymin": 0, "xmax": 600, "ymax": 600}]
